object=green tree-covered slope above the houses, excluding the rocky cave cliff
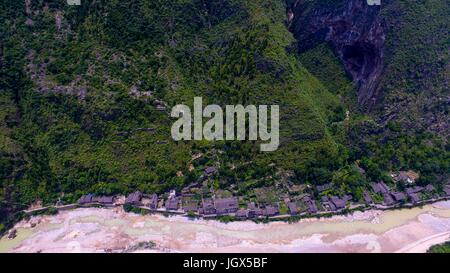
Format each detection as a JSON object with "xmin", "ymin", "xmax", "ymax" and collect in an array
[{"xmin": 0, "ymin": 0, "xmax": 449, "ymax": 231}]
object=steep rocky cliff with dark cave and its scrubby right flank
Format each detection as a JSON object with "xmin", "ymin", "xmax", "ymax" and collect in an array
[{"xmin": 286, "ymin": 0, "xmax": 450, "ymax": 138}]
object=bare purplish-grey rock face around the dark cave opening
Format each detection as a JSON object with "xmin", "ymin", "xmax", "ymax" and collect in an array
[{"xmin": 287, "ymin": 0, "xmax": 385, "ymax": 109}]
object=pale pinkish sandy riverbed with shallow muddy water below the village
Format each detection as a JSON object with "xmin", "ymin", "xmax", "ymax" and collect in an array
[{"xmin": 0, "ymin": 201, "xmax": 450, "ymax": 252}]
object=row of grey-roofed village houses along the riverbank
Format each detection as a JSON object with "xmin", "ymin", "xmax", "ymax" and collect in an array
[{"xmin": 78, "ymin": 171, "xmax": 450, "ymax": 219}]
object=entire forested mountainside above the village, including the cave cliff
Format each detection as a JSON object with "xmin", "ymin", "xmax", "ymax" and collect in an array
[{"xmin": 0, "ymin": 0, "xmax": 449, "ymax": 231}]
